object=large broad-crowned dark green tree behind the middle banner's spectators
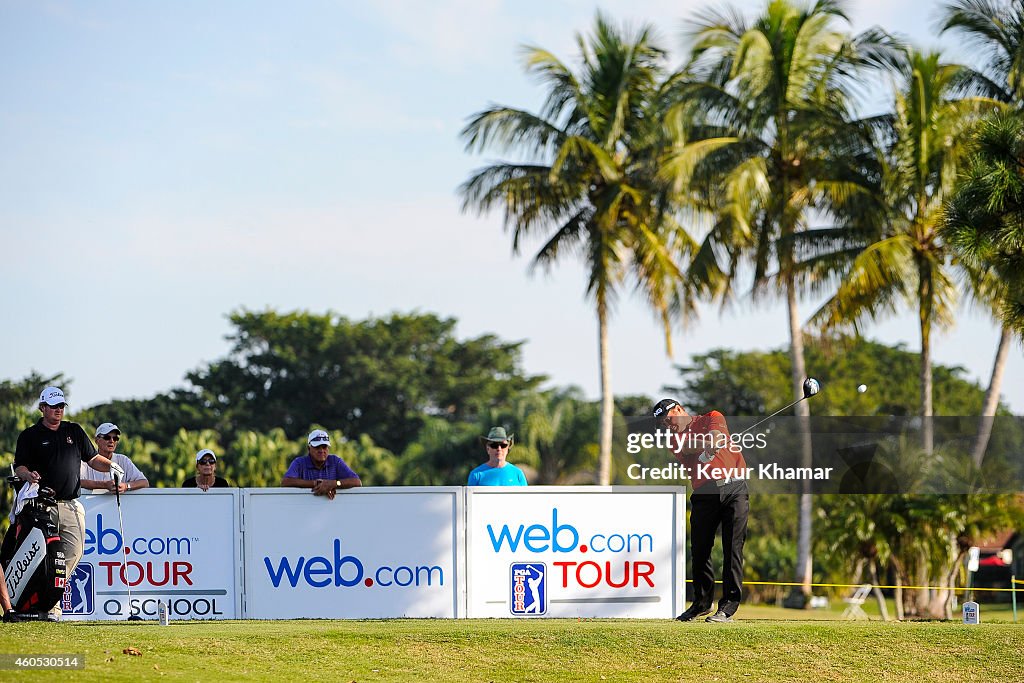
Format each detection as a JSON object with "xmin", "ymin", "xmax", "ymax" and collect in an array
[{"xmin": 169, "ymin": 310, "xmax": 544, "ymax": 452}]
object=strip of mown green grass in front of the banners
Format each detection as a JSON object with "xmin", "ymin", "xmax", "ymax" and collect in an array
[{"xmin": 0, "ymin": 606, "xmax": 1024, "ymax": 683}]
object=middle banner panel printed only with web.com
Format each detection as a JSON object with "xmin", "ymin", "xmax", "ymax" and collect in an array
[{"xmin": 242, "ymin": 486, "xmax": 465, "ymax": 618}]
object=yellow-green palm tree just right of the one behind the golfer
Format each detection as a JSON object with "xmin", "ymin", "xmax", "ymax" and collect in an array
[{"xmin": 814, "ymin": 49, "xmax": 982, "ymax": 452}]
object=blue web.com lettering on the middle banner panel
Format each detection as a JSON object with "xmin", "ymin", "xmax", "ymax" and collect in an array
[{"xmin": 263, "ymin": 539, "xmax": 444, "ymax": 588}]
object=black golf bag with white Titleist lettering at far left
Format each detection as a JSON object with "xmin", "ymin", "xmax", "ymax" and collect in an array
[{"xmin": 0, "ymin": 487, "xmax": 68, "ymax": 614}]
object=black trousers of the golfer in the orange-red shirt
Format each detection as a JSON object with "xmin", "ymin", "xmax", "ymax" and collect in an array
[{"xmin": 690, "ymin": 480, "xmax": 751, "ymax": 616}]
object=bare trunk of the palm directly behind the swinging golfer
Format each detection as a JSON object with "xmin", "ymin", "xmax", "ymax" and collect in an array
[{"xmin": 785, "ymin": 276, "xmax": 814, "ymax": 596}]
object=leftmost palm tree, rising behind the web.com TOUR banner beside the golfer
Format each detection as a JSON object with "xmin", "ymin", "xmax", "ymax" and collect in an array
[{"xmin": 460, "ymin": 14, "xmax": 694, "ymax": 484}]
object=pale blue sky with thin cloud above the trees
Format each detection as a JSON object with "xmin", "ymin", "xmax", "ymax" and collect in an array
[{"xmin": 0, "ymin": 0, "xmax": 1024, "ymax": 413}]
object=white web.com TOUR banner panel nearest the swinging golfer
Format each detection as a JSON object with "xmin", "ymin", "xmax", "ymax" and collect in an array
[{"xmin": 466, "ymin": 486, "xmax": 686, "ymax": 618}]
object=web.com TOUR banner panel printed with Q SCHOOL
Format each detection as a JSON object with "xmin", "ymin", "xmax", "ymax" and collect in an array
[{"xmin": 61, "ymin": 488, "xmax": 242, "ymax": 621}]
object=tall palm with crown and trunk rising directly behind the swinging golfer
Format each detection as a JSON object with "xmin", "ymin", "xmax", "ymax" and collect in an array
[{"xmin": 664, "ymin": 0, "xmax": 890, "ymax": 595}]
